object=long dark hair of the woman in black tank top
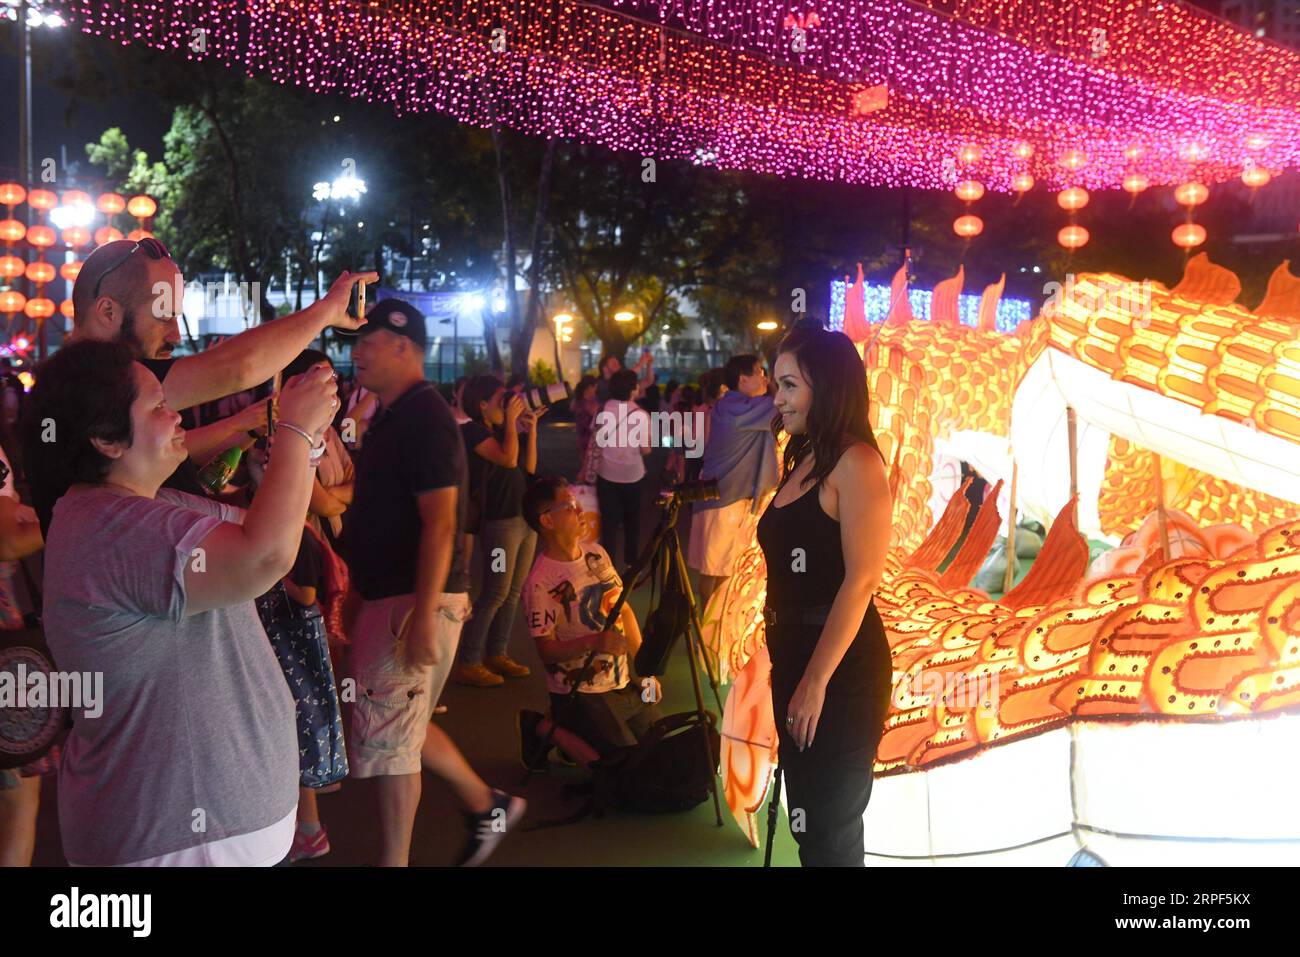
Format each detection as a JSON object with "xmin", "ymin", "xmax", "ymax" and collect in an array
[{"xmin": 772, "ymin": 326, "xmax": 880, "ymax": 486}]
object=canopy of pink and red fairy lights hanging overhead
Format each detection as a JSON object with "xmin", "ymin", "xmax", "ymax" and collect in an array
[{"xmin": 30, "ymin": 0, "xmax": 1300, "ymax": 260}]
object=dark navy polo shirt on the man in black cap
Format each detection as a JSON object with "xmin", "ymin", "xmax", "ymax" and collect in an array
[{"xmin": 343, "ymin": 382, "xmax": 469, "ymax": 601}]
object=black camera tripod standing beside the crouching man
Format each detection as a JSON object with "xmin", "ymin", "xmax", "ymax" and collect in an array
[{"xmin": 520, "ymin": 490, "xmax": 723, "ymax": 827}]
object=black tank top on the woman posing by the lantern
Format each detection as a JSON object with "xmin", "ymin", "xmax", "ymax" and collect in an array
[{"xmin": 758, "ymin": 470, "xmax": 844, "ymax": 607}]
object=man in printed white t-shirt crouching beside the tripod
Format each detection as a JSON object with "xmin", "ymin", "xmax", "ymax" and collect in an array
[{"xmin": 520, "ymin": 479, "xmax": 660, "ymax": 766}]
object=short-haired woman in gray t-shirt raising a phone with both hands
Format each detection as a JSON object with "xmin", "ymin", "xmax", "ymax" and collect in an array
[{"xmin": 26, "ymin": 341, "xmax": 338, "ymax": 865}]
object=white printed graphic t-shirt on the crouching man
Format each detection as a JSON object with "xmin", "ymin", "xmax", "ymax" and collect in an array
[{"xmin": 524, "ymin": 542, "xmax": 628, "ymax": 694}]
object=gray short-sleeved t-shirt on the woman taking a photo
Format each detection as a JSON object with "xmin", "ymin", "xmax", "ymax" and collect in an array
[{"xmin": 44, "ymin": 488, "xmax": 299, "ymax": 865}]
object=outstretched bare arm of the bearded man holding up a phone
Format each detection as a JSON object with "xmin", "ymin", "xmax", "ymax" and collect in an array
[{"xmin": 163, "ymin": 273, "xmax": 380, "ymax": 410}]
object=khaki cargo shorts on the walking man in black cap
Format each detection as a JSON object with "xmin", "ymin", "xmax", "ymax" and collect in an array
[{"xmin": 347, "ymin": 592, "xmax": 471, "ymax": 778}]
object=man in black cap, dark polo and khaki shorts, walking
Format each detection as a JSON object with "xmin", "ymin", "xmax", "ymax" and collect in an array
[{"xmin": 343, "ymin": 299, "xmax": 527, "ymax": 867}]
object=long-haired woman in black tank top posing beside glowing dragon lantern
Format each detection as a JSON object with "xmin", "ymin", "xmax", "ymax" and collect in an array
[{"xmin": 758, "ymin": 328, "xmax": 893, "ymax": 867}]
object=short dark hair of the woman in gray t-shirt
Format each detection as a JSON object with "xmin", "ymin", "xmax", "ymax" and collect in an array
[{"xmin": 21, "ymin": 339, "xmax": 138, "ymax": 502}]
